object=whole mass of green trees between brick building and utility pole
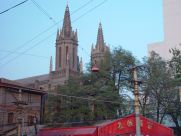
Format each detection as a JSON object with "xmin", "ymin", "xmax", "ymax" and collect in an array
[{"xmin": 46, "ymin": 47, "xmax": 135, "ymax": 122}]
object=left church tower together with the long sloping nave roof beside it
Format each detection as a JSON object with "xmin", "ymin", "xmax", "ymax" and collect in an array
[{"xmin": 16, "ymin": 5, "xmax": 82, "ymax": 91}]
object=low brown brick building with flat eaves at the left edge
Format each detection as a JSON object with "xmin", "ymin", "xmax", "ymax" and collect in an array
[{"xmin": 0, "ymin": 78, "xmax": 46, "ymax": 135}]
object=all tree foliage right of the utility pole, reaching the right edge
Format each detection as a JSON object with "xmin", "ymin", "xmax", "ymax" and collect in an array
[{"xmin": 139, "ymin": 49, "xmax": 181, "ymax": 134}]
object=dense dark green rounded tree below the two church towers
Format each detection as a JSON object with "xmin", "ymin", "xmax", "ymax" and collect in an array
[{"xmin": 44, "ymin": 72, "xmax": 121, "ymax": 122}]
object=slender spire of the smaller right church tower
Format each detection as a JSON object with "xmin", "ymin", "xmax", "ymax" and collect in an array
[{"xmin": 96, "ymin": 23, "xmax": 104, "ymax": 50}]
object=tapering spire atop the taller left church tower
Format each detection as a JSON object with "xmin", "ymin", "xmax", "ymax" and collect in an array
[{"xmin": 62, "ymin": 5, "xmax": 72, "ymax": 37}]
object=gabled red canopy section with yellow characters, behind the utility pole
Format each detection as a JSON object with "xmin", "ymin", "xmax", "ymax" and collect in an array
[{"xmin": 99, "ymin": 114, "xmax": 173, "ymax": 136}]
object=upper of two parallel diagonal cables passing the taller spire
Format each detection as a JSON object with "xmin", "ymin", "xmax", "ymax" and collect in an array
[{"xmin": 0, "ymin": 0, "xmax": 93, "ymax": 60}]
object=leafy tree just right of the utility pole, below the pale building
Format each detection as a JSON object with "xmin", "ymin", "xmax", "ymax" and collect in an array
[{"xmin": 139, "ymin": 52, "xmax": 173, "ymax": 123}]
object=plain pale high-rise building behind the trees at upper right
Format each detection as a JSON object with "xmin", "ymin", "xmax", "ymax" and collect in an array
[{"xmin": 148, "ymin": 0, "xmax": 181, "ymax": 60}]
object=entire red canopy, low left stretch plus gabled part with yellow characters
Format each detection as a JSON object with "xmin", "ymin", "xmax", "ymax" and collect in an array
[{"xmin": 38, "ymin": 114, "xmax": 173, "ymax": 136}]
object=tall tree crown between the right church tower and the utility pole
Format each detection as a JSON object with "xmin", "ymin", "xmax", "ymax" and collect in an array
[{"xmin": 111, "ymin": 47, "xmax": 137, "ymax": 92}]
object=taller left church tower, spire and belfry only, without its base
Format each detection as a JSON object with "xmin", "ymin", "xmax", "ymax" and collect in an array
[{"xmin": 55, "ymin": 5, "xmax": 78, "ymax": 72}]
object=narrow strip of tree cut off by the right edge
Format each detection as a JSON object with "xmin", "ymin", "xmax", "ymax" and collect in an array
[{"xmin": 168, "ymin": 48, "xmax": 181, "ymax": 135}]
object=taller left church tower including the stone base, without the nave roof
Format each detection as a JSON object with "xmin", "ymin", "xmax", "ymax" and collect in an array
[{"xmin": 49, "ymin": 5, "xmax": 79, "ymax": 88}]
